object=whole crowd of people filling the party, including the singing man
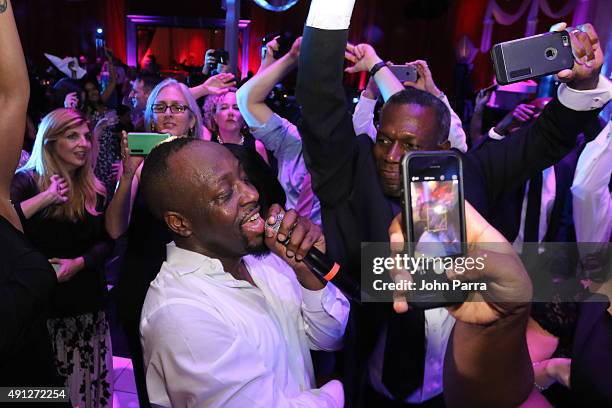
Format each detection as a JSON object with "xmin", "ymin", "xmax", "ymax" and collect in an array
[{"xmin": 0, "ymin": 0, "xmax": 612, "ymax": 408}]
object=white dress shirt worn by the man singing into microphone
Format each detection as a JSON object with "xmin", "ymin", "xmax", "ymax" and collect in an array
[{"xmin": 140, "ymin": 243, "xmax": 349, "ymax": 408}]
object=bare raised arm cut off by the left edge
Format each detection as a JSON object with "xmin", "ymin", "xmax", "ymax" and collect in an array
[{"xmin": 0, "ymin": 0, "xmax": 30, "ymax": 228}]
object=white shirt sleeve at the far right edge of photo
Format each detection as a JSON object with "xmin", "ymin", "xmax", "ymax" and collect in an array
[{"xmin": 572, "ymin": 121, "xmax": 612, "ymax": 242}]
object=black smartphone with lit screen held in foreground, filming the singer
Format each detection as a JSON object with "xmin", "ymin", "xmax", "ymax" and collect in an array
[{"xmin": 402, "ymin": 151, "xmax": 467, "ymax": 309}]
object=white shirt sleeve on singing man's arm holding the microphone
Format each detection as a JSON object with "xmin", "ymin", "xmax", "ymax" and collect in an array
[{"xmin": 302, "ymin": 283, "xmax": 351, "ymax": 351}]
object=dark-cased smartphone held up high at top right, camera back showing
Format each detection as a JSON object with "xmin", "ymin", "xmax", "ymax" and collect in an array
[{"xmin": 491, "ymin": 31, "xmax": 574, "ymax": 85}]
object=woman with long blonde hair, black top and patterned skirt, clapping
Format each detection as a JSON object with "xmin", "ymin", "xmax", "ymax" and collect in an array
[{"xmin": 11, "ymin": 108, "xmax": 112, "ymax": 407}]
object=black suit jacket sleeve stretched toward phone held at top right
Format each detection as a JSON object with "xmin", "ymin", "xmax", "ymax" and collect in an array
[{"xmin": 468, "ymin": 98, "xmax": 598, "ymax": 207}]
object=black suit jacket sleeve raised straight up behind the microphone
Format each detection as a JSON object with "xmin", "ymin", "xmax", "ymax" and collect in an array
[{"xmin": 296, "ymin": 26, "xmax": 357, "ymax": 207}]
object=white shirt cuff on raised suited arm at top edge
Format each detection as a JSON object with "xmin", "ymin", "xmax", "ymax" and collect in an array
[{"xmin": 306, "ymin": 0, "xmax": 355, "ymax": 30}]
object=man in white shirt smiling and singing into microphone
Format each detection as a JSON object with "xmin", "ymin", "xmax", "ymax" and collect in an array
[{"xmin": 140, "ymin": 138, "xmax": 349, "ymax": 408}]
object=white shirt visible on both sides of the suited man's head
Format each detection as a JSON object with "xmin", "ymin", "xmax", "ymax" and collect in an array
[{"xmin": 353, "ymin": 91, "xmax": 467, "ymax": 153}]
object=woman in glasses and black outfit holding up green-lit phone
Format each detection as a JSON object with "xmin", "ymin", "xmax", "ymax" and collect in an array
[{"xmin": 106, "ymin": 79, "xmax": 208, "ymax": 407}]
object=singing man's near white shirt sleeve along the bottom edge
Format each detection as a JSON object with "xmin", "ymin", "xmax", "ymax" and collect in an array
[{"xmin": 145, "ymin": 304, "xmax": 344, "ymax": 408}]
